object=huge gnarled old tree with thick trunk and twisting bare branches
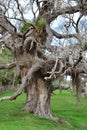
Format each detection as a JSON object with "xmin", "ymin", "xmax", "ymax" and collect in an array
[{"xmin": 0, "ymin": 0, "xmax": 87, "ymax": 120}]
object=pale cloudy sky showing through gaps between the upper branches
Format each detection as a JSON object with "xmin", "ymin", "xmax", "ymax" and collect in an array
[{"xmin": 3, "ymin": 0, "xmax": 87, "ymax": 44}]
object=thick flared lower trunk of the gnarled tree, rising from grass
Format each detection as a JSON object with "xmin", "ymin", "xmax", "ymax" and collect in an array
[{"xmin": 24, "ymin": 78, "xmax": 54, "ymax": 119}]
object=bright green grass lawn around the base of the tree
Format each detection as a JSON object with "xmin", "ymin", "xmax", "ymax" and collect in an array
[{"xmin": 0, "ymin": 91, "xmax": 87, "ymax": 130}]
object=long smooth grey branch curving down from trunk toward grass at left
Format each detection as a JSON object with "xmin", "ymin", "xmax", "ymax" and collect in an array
[{"xmin": 0, "ymin": 60, "xmax": 45, "ymax": 101}]
